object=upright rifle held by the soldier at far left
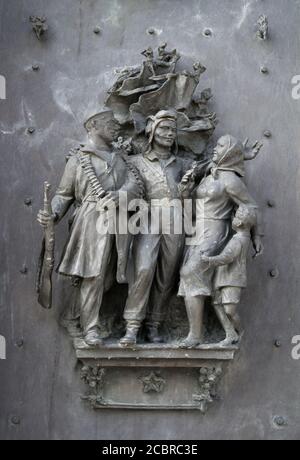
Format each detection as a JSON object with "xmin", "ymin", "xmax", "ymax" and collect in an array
[{"xmin": 36, "ymin": 182, "xmax": 55, "ymax": 309}]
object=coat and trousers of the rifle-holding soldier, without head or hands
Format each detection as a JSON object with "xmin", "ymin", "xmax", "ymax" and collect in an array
[{"xmin": 52, "ymin": 144, "xmax": 139, "ymax": 334}]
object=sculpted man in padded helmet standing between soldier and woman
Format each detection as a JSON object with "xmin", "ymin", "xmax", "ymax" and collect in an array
[{"xmin": 120, "ymin": 110, "xmax": 188, "ymax": 346}]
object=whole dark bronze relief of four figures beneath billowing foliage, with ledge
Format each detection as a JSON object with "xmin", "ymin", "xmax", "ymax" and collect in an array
[{"xmin": 38, "ymin": 44, "xmax": 263, "ymax": 411}]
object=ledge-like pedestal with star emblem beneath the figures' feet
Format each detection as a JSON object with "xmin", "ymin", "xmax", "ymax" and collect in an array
[{"xmin": 74, "ymin": 339, "xmax": 238, "ymax": 413}]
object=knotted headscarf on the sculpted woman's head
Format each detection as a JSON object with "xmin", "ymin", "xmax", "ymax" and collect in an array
[{"xmin": 211, "ymin": 134, "xmax": 245, "ymax": 177}]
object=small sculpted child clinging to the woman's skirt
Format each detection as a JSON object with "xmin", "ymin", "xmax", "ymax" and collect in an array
[{"xmin": 202, "ymin": 205, "xmax": 257, "ymax": 346}]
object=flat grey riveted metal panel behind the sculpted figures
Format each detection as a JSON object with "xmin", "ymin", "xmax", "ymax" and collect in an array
[{"xmin": 0, "ymin": 0, "xmax": 300, "ymax": 439}]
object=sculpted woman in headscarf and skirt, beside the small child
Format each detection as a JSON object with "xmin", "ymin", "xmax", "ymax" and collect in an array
[{"xmin": 178, "ymin": 135, "xmax": 263, "ymax": 348}]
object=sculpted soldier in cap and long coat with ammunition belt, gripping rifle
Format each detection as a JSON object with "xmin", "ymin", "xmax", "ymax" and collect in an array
[{"xmin": 38, "ymin": 111, "xmax": 139, "ymax": 346}]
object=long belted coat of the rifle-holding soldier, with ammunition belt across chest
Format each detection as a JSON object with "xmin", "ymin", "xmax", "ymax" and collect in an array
[{"xmin": 52, "ymin": 145, "xmax": 139, "ymax": 282}]
